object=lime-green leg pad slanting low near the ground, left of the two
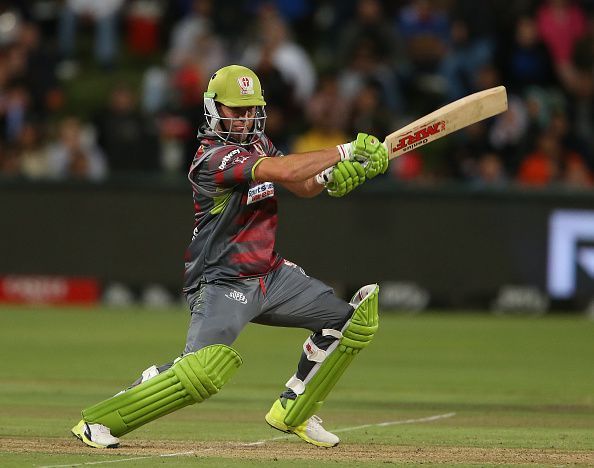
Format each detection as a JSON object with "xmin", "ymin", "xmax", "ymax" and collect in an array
[{"xmin": 82, "ymin": 345, "xmax": 242, "ymax": 437}]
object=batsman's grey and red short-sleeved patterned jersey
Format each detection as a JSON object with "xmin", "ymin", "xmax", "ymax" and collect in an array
[{"xmin": 184, "ymin": 128, "xmax": 282, "ymax": 291}]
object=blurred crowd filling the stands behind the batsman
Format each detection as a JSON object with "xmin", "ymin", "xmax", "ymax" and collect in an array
[{"xmin": 0, "ymin": 0, "xmax": 594, "ymax": 189}]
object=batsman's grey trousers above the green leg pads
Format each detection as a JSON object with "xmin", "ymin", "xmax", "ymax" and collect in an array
[{"xmin": 184, "ymin": 262, "xmax": 353, "ymax": 386}]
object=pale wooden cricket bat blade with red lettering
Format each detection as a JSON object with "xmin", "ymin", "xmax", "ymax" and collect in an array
[{"xmin": 384, "ymin": 86, "xmax": 507, "ymax": 159}]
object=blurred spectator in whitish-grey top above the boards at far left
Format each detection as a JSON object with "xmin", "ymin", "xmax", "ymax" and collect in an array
[{"xmin": 48, "ymin": 117, "xmax": 107, "ymax": 181}]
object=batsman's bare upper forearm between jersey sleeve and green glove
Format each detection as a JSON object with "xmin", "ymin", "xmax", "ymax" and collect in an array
[{"xmin": 254, "ymin": 148, "xmax": 340, "ymax": 183}]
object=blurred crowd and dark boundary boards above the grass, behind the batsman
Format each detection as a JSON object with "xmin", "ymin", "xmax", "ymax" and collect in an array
[{"xmin": 0, "ymin": 0, "xmax": 594, "ymax": 313}]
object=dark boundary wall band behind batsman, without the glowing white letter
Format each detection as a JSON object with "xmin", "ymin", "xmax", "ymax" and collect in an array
[{"xmin": 0, "ymin": 182, "xmax": 594, "ymax": 307}]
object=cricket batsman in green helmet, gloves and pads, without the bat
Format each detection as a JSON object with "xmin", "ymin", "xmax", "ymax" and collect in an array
[{"xmin": 72, "ymin": 65, "xmax": 388, "ymax": 448}]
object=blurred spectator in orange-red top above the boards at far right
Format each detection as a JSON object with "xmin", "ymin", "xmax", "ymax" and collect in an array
[{"xmin": 518, "ymin": 131, "xmax": 592, "ymax": 188}]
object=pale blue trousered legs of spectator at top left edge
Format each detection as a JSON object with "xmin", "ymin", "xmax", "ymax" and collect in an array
[{"xmin": 58, "ymin": 0, "xmax": 124, "ymax": 72}]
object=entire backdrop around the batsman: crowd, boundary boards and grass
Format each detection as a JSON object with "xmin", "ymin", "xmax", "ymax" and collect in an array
[{"xmin": 0, "ymin": 0, "xmax": 594, "ymax": 468}]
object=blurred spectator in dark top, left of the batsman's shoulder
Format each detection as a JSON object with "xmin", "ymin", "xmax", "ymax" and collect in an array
[{"xmin": 94, "ymin": 84, "xmax": 160, "ymax": 174}]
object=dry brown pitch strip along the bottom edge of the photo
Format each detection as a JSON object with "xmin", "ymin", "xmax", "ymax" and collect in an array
[{"xmin": 0, "ymin": 438, "xmax": 594, "ymax": 465}]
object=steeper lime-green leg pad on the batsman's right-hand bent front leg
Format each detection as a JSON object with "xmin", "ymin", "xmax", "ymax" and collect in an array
[{"xmin": 284, "ymin": 285, "xmax": 379, "ymax": 429}]
